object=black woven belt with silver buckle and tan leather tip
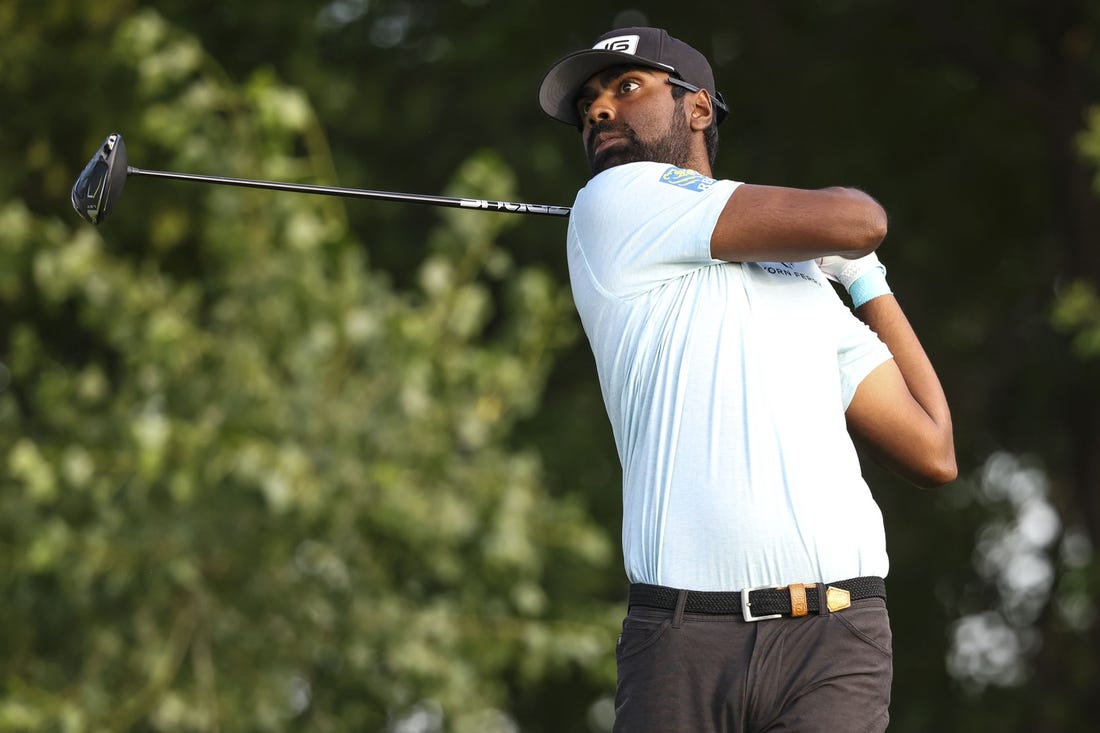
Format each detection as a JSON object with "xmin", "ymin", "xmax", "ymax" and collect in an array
[{"xmin": 629, "ymin": 576, "xmax": 887, "ymax": 621}]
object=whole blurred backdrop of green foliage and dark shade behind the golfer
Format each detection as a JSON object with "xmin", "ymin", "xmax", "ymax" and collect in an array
[{"xmin": 0, "ymin": 0, "xmax": 1100, "ymax": 733}]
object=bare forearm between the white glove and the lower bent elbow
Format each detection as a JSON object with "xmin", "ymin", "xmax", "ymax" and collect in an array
[{"xmin": 856, "ymin": 295, "xmax": 955, "ymax": 469}]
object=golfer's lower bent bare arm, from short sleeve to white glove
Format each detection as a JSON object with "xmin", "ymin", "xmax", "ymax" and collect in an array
[{"xmin": 846, "ymin": 295, "xmax": 958, "ymax": 488}]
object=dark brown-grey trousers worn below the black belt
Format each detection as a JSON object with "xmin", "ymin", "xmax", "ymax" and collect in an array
[{"xmin": 614, "ymin": 598, "xmax": 893, "ymax": 733}]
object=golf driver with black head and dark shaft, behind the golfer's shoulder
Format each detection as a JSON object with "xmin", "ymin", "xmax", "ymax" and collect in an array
[{"xmin": 72, "ymin": 132, "xmax": 570, "ymax": 225}]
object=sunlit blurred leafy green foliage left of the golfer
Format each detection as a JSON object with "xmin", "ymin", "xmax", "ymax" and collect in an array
[{"xmin": 0, "ymin": 8, "xmax": 618, "ymax": 732}]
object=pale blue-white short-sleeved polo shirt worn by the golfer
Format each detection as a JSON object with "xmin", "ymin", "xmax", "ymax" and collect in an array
[{"xmin": 568, "ymin": 163, "xmax": 890, "ymax": 591}]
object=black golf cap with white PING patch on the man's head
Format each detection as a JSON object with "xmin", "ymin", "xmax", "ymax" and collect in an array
[{"xmin": 539, "ymin": 26, "xmax": 728, "ymax": 127}]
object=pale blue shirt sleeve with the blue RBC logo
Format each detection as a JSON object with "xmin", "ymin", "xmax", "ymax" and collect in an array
[{"xmin": 570, "ymin": 163, "xmax": 739, "ymax": 298}]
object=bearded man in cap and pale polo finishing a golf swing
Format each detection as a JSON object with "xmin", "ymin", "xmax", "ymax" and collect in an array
[{"xmin": 539, "ymin": 28, "xmax": 957, "ymax": 733}]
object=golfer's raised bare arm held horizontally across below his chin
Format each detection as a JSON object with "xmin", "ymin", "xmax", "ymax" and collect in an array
[{"xmin": 711, "ymin": 184, "xmax": 887, "ymax": 262}]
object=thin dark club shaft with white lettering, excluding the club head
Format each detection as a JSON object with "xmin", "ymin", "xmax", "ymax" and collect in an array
[{"xmin": 127, "ymin": 165, "xmax": 570, "ymax": 217}]
